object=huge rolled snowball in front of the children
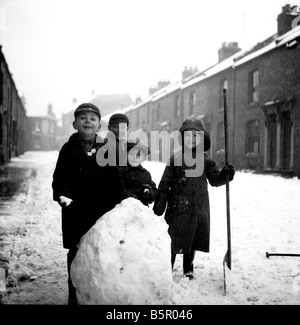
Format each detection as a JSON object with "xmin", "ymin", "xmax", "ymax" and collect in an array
[{"xmin": 71, "ymin": 198, "xmax": 172, "ymax": 305}]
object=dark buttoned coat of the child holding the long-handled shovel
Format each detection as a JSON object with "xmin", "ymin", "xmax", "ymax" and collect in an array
[{"xmin": 153, "ymin": 149, "xmax": 230, "ymax": 253}]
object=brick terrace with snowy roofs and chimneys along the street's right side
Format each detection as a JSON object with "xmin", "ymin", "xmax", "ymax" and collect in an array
[{"xmin": 110, "ymin": 5, "xmax": 300, "ymax": 177}]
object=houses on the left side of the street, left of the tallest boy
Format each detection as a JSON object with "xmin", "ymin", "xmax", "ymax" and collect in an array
[{"xmin": 0, "ymin": 42, "xmax": 62, "ymax": 166}]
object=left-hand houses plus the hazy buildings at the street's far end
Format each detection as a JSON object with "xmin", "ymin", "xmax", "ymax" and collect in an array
[{"xmin": 0, "ymin": 40, "xmax": 133, "ymax": 166}]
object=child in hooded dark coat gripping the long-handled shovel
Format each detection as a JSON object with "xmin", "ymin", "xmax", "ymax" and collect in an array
[{"xmin": 153, "ymin": 119, "xmax": 235, "ymax": 279}]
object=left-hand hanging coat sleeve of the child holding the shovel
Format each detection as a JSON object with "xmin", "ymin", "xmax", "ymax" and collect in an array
[{"xmin": 153, "ymin": 165, "xmax": 173, "ymax": 216}]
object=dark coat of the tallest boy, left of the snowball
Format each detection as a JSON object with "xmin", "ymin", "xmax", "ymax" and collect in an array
[{"xmin": 52, "ymin": 133, "xmax": 126, "ymax": 248}]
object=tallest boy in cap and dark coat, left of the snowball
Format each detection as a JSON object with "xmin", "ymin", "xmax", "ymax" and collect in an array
[{"xmin": 52, "ymin": 103, "xmax": 128, "ymax": 304}]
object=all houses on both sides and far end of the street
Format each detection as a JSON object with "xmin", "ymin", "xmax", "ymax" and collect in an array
[{"xmin": 0, "ymin": 5, "xmax": 300, "ymax": 177}]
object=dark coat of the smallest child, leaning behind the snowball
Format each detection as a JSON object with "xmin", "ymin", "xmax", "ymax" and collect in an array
[{"xmin": 122, "ymin": 165, "xmax": 158, "ymax": 206}]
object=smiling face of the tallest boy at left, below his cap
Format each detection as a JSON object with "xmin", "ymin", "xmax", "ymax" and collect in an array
[{"xmin": 73, "ymin": 112, "xmax": 101, "ymax": 139}]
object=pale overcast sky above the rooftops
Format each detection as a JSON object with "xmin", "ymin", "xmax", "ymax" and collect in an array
[{"xmin": 0, "ymin": 0, "xmax": 300, "ymax": 118}]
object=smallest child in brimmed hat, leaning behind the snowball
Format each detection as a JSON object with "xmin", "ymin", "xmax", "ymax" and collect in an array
[{"xmin": 122, "ymin": 140, "xmax": 158, "ymax": 206}]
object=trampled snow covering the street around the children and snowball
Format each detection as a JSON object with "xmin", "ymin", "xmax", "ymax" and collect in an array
[{"xmin": 0, "ymin": 151, "xmax": 300, "ymax": 305}]
